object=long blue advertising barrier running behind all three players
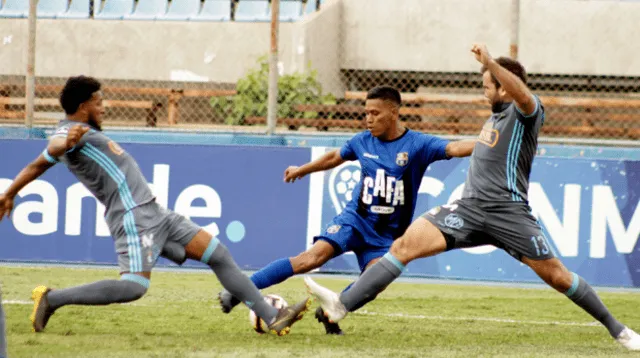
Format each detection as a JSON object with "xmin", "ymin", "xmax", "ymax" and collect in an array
[{"xmin": 0, "ymin": 128, "xmax": 640, "ymax": 286}]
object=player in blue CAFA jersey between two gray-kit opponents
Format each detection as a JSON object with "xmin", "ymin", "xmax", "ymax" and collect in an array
[{"xmin": 219, "ymin": 86, "xmax": 475, "ymax": 334}]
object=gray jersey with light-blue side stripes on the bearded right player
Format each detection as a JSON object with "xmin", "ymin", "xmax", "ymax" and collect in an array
[{"xmin": 462, "ymin": 97, "xmax": 544, "ymax": 202}]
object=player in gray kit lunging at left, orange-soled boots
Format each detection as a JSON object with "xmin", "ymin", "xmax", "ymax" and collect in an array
[{"xmin": 0, "ymin": 76, "xmax": 310, "ymax": 335}]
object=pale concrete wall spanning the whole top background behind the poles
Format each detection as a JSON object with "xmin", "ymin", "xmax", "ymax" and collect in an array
[{"xmin": 0, "ymin": 0, "xmax": 640, "ymax": 85}]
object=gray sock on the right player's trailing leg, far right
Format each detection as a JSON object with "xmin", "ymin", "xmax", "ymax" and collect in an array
[{"xmin": 565, "ymin": 273, "xmax": 624, "ymax": 338}]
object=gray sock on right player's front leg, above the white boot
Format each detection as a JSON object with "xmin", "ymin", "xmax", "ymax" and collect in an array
[{"xmin": 340, "ymin": 252, "xmax": 404, "ymax": 312}]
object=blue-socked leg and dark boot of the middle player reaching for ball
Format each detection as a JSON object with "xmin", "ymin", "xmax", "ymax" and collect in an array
[{"xmin": 218, "ymin": 240, "xmax": 335, "ymax": 313}]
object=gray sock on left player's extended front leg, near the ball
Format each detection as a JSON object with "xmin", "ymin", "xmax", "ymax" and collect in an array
[{"xmin": 200, "ymin": 238, "xmax": 278, "ymax": 323}]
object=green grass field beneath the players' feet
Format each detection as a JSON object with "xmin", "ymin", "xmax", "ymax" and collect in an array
[{"xmin": 0, "ymin": 267, "xmax": 640, "ymax": 358}]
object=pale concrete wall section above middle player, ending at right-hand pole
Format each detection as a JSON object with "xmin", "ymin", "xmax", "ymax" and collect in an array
[{"xmin": 343, "ymin": 0, "xmax": 510, "ymax": 71}]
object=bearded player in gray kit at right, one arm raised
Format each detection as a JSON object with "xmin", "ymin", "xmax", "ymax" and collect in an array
[{"xmin": 305, "ymin": 45, "xmax": 640, "ymax": 350}]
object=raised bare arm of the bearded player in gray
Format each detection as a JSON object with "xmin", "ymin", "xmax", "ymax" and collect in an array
[{"xmin": 471, "ymin": 44, "xmax": 536, "ymax": 116}]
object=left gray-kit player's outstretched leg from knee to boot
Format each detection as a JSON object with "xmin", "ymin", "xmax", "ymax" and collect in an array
[{"xmin": 185, "ymin": 230, "xmax": 311, "ymax": 335}]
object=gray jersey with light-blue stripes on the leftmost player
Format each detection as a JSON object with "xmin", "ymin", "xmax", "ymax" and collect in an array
[{"xmin": 45, "ymin": 120, "xmax": 155, "ymax": 222}]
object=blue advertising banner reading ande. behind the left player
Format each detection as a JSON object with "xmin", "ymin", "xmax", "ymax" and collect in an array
[{"xmin": 0, "ymin": 140, "xmax": 310, "ymax": 269}]
